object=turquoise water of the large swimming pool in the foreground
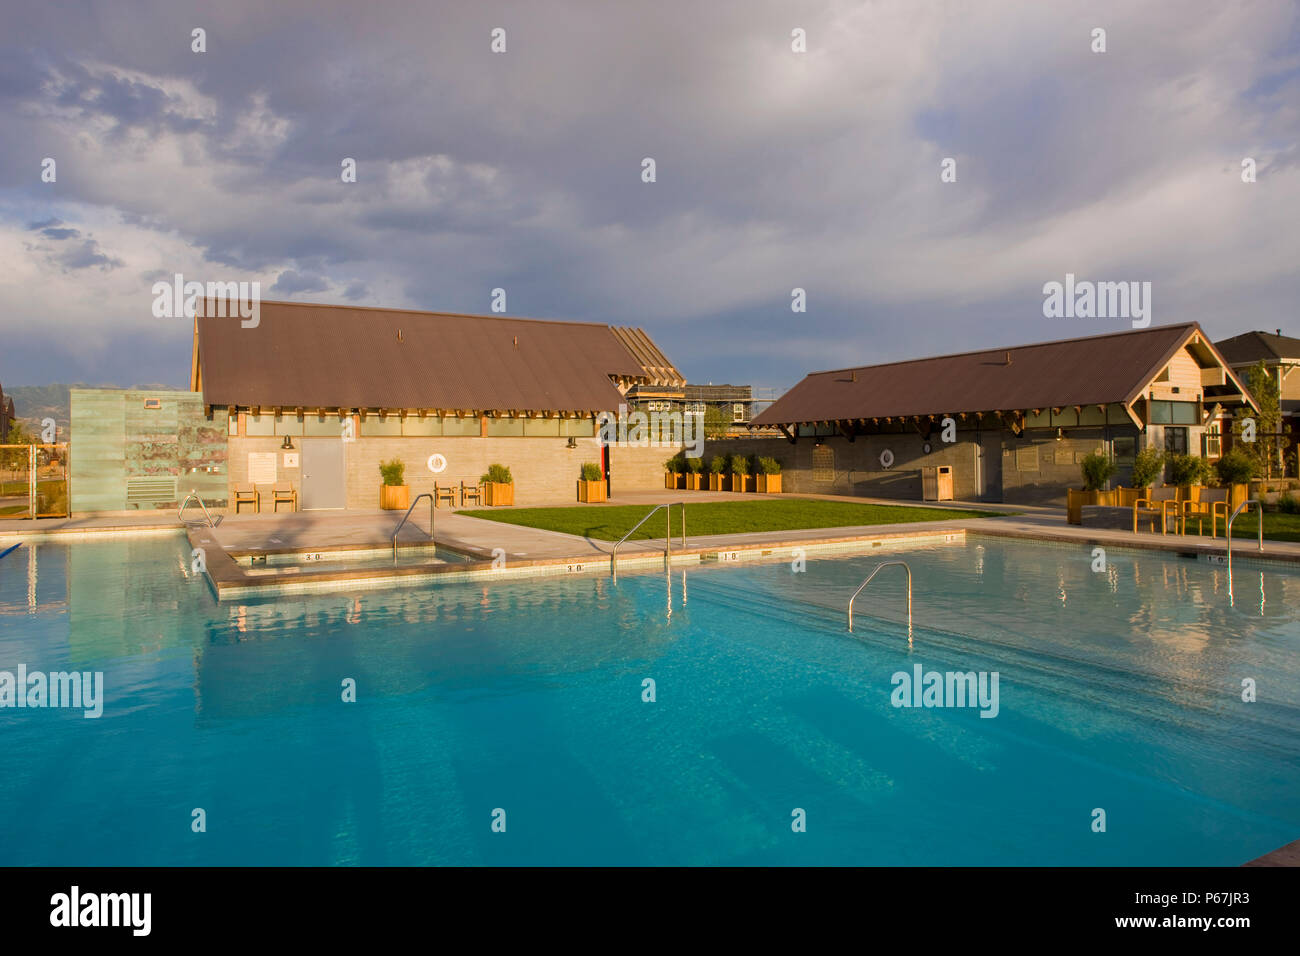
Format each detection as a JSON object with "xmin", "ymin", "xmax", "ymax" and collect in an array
[{"xmin": 0, "ymin": 538, "xmax": 1300, "ymax": 865}]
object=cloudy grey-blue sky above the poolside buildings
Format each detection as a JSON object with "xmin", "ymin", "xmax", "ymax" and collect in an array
[{"xmin": 0, "ymin": 0, "xmax": 1300, "ymax": 386}]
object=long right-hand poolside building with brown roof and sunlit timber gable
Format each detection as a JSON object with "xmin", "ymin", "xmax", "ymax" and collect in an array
[{"xmin": 751, "ymin": 323, "xmax": 1253, "ymax": 503}]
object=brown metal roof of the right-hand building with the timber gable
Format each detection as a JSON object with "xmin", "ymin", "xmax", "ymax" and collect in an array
[{"xmin": 751, "ymin": 323, "xmax": 1237, "ymax": 425}]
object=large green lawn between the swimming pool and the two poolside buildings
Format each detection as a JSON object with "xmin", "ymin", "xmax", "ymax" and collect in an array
[{"xmin": 460, "ymin": 498, "xmax": 1003, "ymax": 541}]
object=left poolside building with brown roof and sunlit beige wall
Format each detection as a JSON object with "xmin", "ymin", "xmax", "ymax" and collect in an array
[{"xmin": 191, "ymin": 302, "xmax": 684, "ymax": 509}]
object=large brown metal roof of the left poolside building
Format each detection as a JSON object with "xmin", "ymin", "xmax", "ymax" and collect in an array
[{"xmin": 195, "ymin": 302, "xmax": 646, "ymax": 412}]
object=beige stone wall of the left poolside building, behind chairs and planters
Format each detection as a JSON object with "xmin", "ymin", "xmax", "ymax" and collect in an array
[{"xmin": 229, "ymin": 436, "xmax": 672, "ymax": 510}]
